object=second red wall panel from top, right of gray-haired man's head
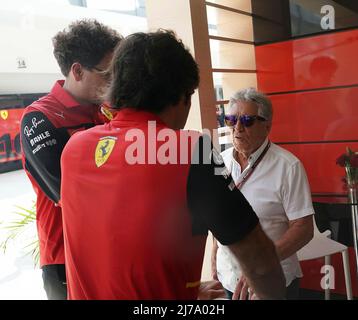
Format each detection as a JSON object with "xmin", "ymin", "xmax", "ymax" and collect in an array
[{"xmin": 270, "ymin": 87, "xmax": 358, "ymax": 142}]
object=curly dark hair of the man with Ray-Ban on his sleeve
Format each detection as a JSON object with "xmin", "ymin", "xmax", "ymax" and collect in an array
[{"xmin": 52, "ymin": 19, "xmax": 122, "ymax": 77}]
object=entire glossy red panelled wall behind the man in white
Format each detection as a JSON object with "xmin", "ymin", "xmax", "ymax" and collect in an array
[{"xmin": 255, "ymin": 29, "xmax": 358, "ymax": 296}]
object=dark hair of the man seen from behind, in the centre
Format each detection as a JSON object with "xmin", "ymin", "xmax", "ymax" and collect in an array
[{"xmin": 108, "ymin": 30, "xmax": 199, "ymax": 113}]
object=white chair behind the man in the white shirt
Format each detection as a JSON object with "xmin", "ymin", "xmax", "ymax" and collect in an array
[{"xmin": 297, "ymin": 219, "xmax": 353, "ymax": 300}]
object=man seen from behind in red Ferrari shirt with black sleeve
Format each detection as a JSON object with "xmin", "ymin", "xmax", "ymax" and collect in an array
[{"xmin": 61, "ymin": 31, "xmax": 285, "ymax": 300}]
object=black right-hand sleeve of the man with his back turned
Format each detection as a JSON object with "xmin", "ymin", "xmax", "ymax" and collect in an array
[{"xmin": 187, "ymin": 136, "xmax": 259, "ymax": 245}]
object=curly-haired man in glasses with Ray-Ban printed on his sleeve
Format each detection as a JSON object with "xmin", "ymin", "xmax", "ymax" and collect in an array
[{"xmin": 21, "ymin": 20, "xmax": 121, "ymax": 299}]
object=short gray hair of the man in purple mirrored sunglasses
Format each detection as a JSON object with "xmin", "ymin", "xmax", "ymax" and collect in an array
[{"xmin": 229, "ymin": 88, "xmax": 273, "ymax": 120}]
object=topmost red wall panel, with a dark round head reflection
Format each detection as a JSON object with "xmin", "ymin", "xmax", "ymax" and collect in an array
[{"xmin": 255, "ymin": 30, "xmax": 358, "ymax": 93}]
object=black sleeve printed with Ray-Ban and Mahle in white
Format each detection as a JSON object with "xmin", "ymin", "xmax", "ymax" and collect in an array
[{"xmin": 21, "ymin": 111, "xmax": 68, "ymax": 203}]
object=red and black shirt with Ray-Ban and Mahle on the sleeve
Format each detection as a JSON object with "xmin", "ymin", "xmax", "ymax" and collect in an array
[{"xmin": 21, "ymin": 81, "xmax": 104, "ymax": 266}]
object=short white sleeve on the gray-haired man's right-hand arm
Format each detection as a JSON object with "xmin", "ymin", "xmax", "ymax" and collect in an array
[{"xmin": 282, "ymin": 161, "xmax": 314, "ymax": 220}]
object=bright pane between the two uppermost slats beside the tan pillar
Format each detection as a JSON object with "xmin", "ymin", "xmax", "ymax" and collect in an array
[{"xmin": 206, "ymin": 6, "xmax": 253, "ymax": 41}]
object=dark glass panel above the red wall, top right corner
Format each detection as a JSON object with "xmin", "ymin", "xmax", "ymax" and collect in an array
[{"xmin": 252, "ymin": 0, "xmax": 358, "ymax": 44}]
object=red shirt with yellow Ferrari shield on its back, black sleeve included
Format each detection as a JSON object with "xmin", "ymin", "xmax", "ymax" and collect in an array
[{"xmin": 61, "ymin": 109, "xmax": 258, "ymax": 299}]
